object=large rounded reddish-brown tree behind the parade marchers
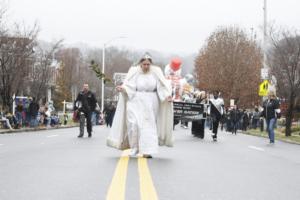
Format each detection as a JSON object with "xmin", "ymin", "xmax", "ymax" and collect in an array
[{"xmin": 195, "ymin": 27, "xmax": 262, "ymax": 108}]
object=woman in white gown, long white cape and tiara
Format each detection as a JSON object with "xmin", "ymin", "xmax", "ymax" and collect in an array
[{"xmin": 107, "ymin": 54, "xmax": 173, "ymax": 158}]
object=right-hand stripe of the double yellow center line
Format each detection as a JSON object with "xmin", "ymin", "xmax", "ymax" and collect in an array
[{"xmin": 138, "ymin": 157, "xmax": 158, "ymax": 200}]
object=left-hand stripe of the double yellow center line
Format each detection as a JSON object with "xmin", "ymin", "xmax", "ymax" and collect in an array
[{"xmin": 106, "ymin": 150, "xmax": 129, "ymax": 200}]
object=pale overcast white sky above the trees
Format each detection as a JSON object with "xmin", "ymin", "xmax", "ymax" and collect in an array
[{"xmin": 8, "ymin": 0, "xmax": 300, "ymax": 54}]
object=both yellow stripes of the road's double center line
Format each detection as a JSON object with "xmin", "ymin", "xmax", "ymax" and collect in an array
[{"xmin": 106, "ymin": 150, "xmax": 158, "ymax": 200}]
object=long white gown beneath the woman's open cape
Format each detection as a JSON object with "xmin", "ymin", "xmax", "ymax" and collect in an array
[{"xmin": 126, "ymin": 72, "xmax": 159, "ymax": 154}]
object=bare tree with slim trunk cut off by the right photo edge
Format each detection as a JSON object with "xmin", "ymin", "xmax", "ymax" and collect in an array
[{"xmin": 268, "ymin": 30, "xmax": 300, "ymax": 136}]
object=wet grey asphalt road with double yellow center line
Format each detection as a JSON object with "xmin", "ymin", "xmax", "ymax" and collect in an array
[{"xmin": 0, "ymin": 126, "xmax": 300, "ymax": 200}]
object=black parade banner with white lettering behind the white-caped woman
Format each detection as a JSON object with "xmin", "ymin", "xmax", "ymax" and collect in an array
[{"xmin": 173, "ymin": 102, "xmax": 206, "ymax": 120}]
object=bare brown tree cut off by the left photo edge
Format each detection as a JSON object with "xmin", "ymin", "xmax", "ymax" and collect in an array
[{"xmin": 0, "ymin": 21, "xmax": 39, "ymax": 109}]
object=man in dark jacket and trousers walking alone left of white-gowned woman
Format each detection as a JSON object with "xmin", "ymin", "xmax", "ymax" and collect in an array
[{"xmin": 74, "ymin": 84, "xmax": 97, "ymax": 138}]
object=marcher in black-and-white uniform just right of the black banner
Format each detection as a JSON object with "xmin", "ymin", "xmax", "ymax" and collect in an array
[{"xmin": 208, "ymin": 91, "xmax": 224, "ymax": 142}]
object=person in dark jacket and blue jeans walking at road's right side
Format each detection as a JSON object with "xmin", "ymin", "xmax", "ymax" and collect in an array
[{"xmin": 261, "ymin": 91, "xmax": 280, "ymax": 144}]
